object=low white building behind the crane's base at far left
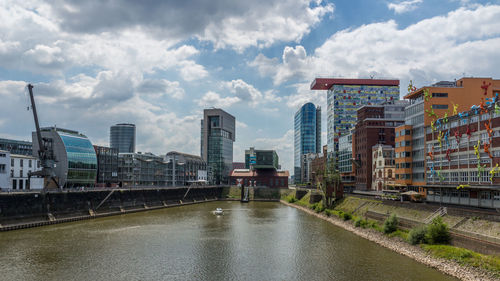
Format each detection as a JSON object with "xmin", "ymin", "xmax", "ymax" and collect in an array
[{"xmin": 8, "ymin": 154, "xmax": 43, "ymax": 190}]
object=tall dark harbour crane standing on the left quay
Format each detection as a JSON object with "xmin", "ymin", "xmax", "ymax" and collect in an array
[{"xmin": 27, "ymin": 84, "xmax": 60, "ymax": 189}]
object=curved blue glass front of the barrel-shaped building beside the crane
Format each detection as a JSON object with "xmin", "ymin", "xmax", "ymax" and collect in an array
[{"xmin": 58, "ymin": 132, "xmax": 97, "ymax": 187}]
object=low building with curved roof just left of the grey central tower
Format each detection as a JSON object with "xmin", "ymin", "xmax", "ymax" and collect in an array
[{"xmin": 164, "ymin": 151, "xmax": 207, "ymax": 186}]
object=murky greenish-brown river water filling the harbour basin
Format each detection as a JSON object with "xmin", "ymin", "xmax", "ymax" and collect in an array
[{"xmin": 0, "ymin": 202, "xmax": 455, "ymax": 280}]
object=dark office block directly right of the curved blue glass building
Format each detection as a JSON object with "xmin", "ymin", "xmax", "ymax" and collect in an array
[{"xmin": 94, "ymin": 145, "xmax": 120, "ymax": 187}]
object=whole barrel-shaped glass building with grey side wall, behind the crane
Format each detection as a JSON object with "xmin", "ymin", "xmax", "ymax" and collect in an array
[{"xmin": 32, "ymin": 127, "xmax": 97, "ymax": 188}]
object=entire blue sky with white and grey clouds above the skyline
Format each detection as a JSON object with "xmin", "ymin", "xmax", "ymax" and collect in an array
[{"xmin": 0, "ymin": 0, "xmax": 500, "ymax": 171}]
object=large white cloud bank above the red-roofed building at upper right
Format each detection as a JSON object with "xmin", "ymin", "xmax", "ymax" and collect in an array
[{"xmin": 250, "ymin": 5, "xmax": 500, "ymax": 102}]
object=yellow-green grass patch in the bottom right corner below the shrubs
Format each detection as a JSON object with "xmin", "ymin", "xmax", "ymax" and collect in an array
[{"xmin": 421, "ymin": 244, "xmax": 500, "ymax": 278}]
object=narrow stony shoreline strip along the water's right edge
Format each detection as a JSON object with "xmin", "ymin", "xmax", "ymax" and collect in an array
[{"xmin": 281, "ymin": 200, "xmax": 498, "ymax": 281}]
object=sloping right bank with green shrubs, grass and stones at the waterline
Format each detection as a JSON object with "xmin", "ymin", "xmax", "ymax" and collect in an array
[{"xmin": 282, "ymin": 189, "xmax": 500, "ymax": 280}]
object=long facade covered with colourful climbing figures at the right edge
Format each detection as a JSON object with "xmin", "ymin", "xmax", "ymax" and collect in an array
[{"xmin": 425, "ymin": 87, "xmax": 500, "ymax": 208}]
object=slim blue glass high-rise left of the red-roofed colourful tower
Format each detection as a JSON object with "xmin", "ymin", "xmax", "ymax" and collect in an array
[{"xmin": 294, "ymin": 102, "xmax": 321, "ymax": 182}]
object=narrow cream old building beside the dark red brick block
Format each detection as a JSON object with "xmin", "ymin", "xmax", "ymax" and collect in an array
[{"xmin": 371, "ymin": 144, "xmax": 396, "ymax": 191}]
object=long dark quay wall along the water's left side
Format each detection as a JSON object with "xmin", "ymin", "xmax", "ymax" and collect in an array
[{"xmin": 0, "ymin": 186, "xmax": 223, "ymax": 231}]
